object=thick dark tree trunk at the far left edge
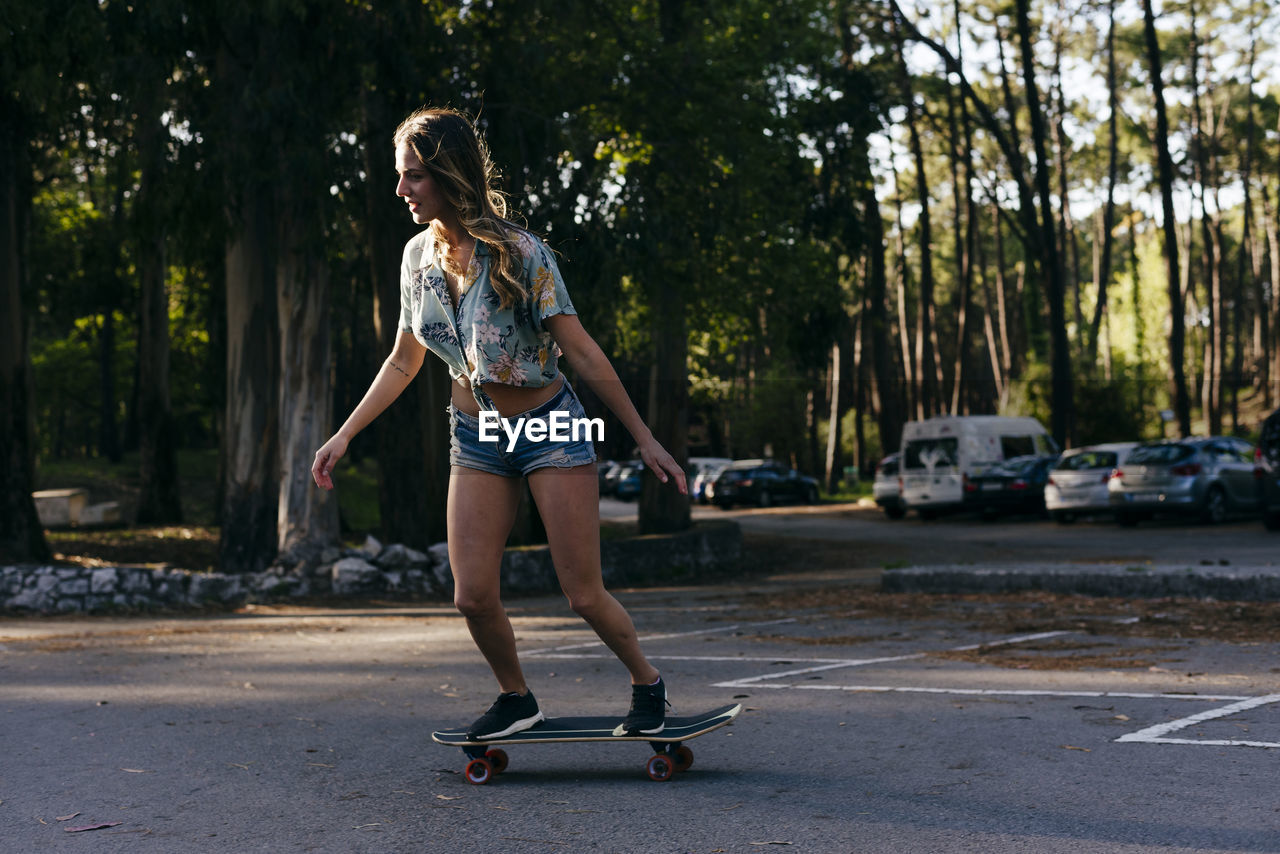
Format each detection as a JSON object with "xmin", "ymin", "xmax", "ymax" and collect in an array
[{"xmin": 0, "ymin": 90, "xmax": 50, "ymax": 563}]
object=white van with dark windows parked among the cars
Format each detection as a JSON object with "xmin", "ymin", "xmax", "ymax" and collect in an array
[{"xmin": 899, "ymin": 415, "xmax": 1059, "ymax": 519}]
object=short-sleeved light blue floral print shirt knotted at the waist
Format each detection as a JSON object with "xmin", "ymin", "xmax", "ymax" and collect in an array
[{"xmin": 401, "ymin": 229, "xmax": 577, "ymax": 410}]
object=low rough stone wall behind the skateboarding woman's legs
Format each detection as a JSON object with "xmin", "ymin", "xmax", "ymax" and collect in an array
[{"xmin": 0, "ymin": 520, "xmax": 742, "ymax": 613}]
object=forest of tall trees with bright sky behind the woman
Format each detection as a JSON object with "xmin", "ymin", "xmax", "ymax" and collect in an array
[{"xmin": 0, "ymin": 0, "xmax": 1280, "ymax": 571}]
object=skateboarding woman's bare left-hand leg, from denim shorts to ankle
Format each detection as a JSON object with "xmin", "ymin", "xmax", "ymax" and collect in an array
[{"xmin": 447, "ymin": 466, "xmax": 527, "ymax": 694}]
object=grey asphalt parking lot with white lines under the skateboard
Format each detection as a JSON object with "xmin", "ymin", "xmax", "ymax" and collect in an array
[{"xmin": 0, "ymin": 577, "xmax": 1280, "ymax": 854}]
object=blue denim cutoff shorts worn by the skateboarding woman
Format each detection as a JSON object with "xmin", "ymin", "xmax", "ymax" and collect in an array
[{"xmin": 449, "ymin": 379, "xmax": 599, "ymax": 478}]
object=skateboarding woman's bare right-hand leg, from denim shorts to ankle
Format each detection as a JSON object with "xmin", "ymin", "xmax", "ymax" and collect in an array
[{"xmin": 524, "ymin": 463, "xmax": 658, "ymax": 685}]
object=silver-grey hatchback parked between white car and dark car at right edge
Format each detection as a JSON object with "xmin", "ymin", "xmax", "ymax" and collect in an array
[{"xmin": 1107, "ymin": 437, "xmax": 1260, "ymax": 525}]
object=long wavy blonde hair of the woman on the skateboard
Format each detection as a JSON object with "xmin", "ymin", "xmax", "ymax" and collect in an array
[{"xmin": 394, "ymin": 108, "xmax": 529, "ymax": 309}]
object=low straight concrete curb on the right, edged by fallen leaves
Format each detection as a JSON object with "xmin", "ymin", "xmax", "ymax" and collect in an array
[{"xmin": 881, "ymin": 565, "xmax": 1280, "ymax": 602}]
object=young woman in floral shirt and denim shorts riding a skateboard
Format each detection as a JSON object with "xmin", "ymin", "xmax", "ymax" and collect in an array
[{"xmin": 311, "ymin": 109, "xmax": 687, "ymax": 740}]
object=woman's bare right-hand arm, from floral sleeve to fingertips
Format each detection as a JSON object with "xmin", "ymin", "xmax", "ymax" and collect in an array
[{"xmin": 543, "ymin": 314, "xmax": 689, "ymax": 495}]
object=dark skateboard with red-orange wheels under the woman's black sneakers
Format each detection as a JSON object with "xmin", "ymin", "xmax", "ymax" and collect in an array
[{"xmin": 431, "ymin": 704, "xmax": 742, "ymax": 786}]
